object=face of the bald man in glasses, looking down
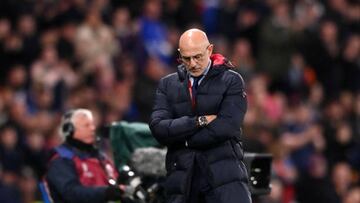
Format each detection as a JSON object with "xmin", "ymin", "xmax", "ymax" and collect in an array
[{"xmin": 179, "ymin": 44, "xmax": 213, "ymax": 77}]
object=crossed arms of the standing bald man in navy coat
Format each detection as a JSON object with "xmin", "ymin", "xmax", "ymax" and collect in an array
[{"xmin": 150, "ymin": 74, "xmax": 247, "ymax": 148}]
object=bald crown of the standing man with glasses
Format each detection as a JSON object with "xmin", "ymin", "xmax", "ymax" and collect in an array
[{"xmin": 179, "ymin": 28, "xmax": 210, "ymax": 52}]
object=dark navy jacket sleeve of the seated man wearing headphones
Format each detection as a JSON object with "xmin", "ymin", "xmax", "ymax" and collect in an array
[{"xmin": 46, "ymin": 158, "xmax": 108, "ymax": 203}]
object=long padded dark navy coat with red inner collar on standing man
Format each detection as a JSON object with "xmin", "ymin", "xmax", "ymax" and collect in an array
[{"xmin": 150, "ymin": 54, "xmax": 251, "ymax": 203}]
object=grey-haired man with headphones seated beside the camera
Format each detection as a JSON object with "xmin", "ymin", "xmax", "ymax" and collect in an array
[{"xmin": 45, "ymin": 109, "xmax": 125, "ymax": 203}]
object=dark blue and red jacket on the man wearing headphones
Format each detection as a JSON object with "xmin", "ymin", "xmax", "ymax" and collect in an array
[{"xmin": 45, "ymin": 140, "xmax": 118, "ymax": 203}]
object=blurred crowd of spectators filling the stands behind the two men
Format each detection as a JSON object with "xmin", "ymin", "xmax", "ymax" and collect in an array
[{"xmin": 0, "ymin": 0, "xmax": 360, "ymax": 203}]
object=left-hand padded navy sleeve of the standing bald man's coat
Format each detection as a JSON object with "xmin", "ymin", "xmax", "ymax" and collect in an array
[{"xmin": 150, "ymin": 78, "xmax": 197, "ymax": 146}]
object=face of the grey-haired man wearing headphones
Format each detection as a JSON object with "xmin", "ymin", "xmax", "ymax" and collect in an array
[{"xmin": 74, "ymin": 114, "xmax": 96, "ymax": 144}]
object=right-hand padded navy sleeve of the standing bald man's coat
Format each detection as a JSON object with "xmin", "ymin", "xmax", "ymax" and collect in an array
[{"xmin": 188, "ymin": 74, "xmax": 247, "ymax": 148}]
